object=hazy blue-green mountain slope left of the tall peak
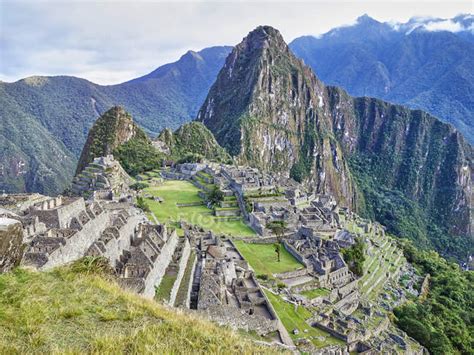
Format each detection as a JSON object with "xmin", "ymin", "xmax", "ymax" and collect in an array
[{"xmin": 0, "ymin": 47, "xmax": 230, "ymax": 194}]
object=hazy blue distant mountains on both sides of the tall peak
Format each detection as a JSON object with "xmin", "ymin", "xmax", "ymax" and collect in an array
[{"xmin": 0, "ymin": 15, "xmax": 474, "ymax": 194}]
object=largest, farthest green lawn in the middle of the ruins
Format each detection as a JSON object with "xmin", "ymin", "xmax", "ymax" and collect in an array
[{"xmin": 143, "ymin": 180, "xmax": 255, "ymax": 236}]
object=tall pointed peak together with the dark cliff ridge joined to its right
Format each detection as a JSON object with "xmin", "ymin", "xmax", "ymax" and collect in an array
[{"xmin": 197, "ymin": 27, "xmax": 473, "ymax": 260}]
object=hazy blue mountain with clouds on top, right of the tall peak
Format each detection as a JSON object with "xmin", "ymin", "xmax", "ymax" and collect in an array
[{"xmin": 290, "ymin": 15, "xmax": 474, "ymax": 143}]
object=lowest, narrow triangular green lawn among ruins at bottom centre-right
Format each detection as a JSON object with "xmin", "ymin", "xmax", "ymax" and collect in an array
[{"xmin": 264, "ymin": 290, "xmax": 345, "ymax": 348}]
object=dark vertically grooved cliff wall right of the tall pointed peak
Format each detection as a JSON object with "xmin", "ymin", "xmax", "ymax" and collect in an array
[{"xmin": 327, "ymin": 87, "xmax": 474, "ymax": 242}]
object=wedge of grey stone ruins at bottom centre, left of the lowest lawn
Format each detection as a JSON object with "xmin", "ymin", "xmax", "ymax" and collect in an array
[{"xmin": 185, "ymin": 228, "xmax": 293, "ymax": 345}]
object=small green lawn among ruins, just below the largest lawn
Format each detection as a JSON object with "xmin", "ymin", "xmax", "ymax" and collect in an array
[{"xmin": 234, "ymin": 240, "xmax": 303, "ymax": 275}]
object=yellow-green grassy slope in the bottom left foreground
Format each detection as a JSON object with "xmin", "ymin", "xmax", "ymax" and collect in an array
[{"xmin": 0, "ymin": 258, "xmax": 275, "ymax": 354}]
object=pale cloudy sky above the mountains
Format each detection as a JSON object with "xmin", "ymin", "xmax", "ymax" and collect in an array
[{"xmin": 0, "ymin": 0, "xmax": 474, "ymax": 85}]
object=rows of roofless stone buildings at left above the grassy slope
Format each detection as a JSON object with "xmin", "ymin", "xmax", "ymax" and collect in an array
[{"xmin": 0, "ymin": 192, "xmax": 178, "ymax": 298}]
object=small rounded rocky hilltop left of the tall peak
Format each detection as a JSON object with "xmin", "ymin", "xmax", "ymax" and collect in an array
[{"xmin": 76, "ymin": 106, "xmax": 146, "ymax": 175}]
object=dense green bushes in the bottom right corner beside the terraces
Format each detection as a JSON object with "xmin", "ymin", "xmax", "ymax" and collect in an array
[{"xmin": 394, "ymin": 241, "xmax": 474, "ymax": 355}]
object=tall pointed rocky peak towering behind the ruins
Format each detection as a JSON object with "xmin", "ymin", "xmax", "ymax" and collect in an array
[{"xmin": 197, "ymin": 26, "xmax": 354, "ymax": 206}]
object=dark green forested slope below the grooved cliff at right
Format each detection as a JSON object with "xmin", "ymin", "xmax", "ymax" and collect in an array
[{"xmin": 350, "ymin": 155, "xmax": 473, "ymax": 260}]
